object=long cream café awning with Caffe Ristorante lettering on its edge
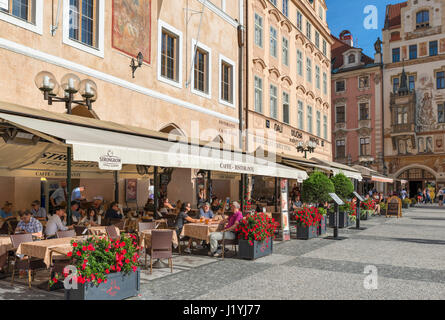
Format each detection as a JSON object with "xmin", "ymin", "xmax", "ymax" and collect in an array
[{"xmin": 0, "ymin": 109, "xmax": 307, "ymax": 181}]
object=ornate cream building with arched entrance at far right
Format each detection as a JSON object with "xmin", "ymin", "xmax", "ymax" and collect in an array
[{"xmin": 383, "ymin": 0, "xmax": 445, "ymax": 197}]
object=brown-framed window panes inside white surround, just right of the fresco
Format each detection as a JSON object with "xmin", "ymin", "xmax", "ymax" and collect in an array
[{"xmin": 161, "ymin": 29, "xmax": 180, "ymax": 82}]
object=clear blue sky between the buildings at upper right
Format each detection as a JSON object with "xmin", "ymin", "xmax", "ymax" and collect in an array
[{"xmin": 326, "ymin": 0, "xmax": 404, "ymax": 58}]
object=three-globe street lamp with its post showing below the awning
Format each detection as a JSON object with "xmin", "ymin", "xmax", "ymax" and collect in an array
[{"xmin": 34, "ymin": 71, "xmax": 97, "ymax": 225}]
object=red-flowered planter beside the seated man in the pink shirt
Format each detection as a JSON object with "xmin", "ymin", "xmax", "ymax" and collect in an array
[{"xmin": 236, "ymin": 212, "xmax": 276, "ymax": 260}]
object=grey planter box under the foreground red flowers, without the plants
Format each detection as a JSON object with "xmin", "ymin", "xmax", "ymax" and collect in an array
[{"xmin": 65, "ymin": 269, "xmax": 141, "ymax": 300}]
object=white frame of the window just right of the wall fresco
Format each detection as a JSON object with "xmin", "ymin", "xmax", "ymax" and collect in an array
[{"xmin": 158, "ymin": 20, "xmax": 183, "ymax": 89}]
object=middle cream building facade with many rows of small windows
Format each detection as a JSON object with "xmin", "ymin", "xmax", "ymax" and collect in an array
[{"xmin": 246, "ymin": 0, "xmax": 333, "ymax": 161}]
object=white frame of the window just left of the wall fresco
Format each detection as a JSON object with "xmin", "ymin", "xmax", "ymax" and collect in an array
[{"xmin": 62, "ymin": 0, "xmax": 105, "ymax": 58}]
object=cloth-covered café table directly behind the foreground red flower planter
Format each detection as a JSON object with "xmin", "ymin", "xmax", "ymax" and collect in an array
[{"xmin": 16, "ymin": 236, "xmax": 86, "ymax": 268}]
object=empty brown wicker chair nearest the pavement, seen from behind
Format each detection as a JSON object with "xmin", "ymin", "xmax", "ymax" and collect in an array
[{"xmin": 150, "ymin": 230, "xmax": 174, "ymax": 274}]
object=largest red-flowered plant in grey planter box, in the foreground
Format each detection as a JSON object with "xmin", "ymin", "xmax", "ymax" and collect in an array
[{"xmin": 50, "ymin": 234, "xmax": 140, "ymax": 300}]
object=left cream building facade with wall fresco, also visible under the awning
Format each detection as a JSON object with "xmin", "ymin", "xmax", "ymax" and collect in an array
[{"xmin": 0, "ymin": 0, "xmax": 243, "ymax": 209}]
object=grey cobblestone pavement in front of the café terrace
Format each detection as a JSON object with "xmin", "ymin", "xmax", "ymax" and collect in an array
[{"xmin": 0, "ymin": 208, "xmax": 445, "ymax": 300}]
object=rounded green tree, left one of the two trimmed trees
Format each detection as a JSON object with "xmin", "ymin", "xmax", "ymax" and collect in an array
[{"xmin": 301, "ymin": 171, "xmax": 335, "ymax": 204}]
